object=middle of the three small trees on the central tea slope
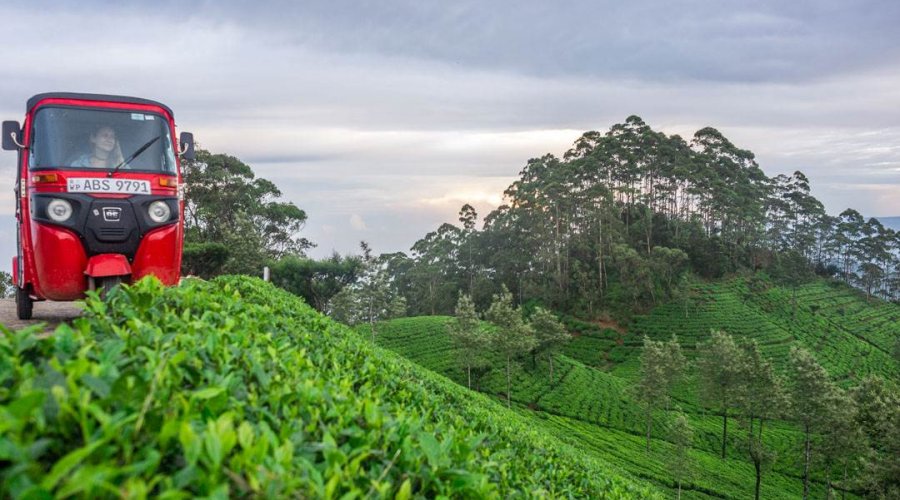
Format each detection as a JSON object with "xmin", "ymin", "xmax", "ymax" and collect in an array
[{"xmin": 485, "ymin": 286, "xmax": 537, "ymax": 407}]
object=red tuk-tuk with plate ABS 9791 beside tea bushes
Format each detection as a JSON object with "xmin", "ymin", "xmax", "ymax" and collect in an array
[{"xmin": 2, "ymin": 92, "xmax": 194, "ymax": 319}]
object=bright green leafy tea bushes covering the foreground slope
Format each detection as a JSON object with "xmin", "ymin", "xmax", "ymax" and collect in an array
[{"xmin": 0, "ymin": 277, "xmax": 659, "ymax": 499}]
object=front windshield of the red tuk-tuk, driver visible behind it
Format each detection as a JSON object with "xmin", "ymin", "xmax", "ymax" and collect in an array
[{"xmin": 29, "ymin": 107, "xmax": 175, "ymax": 174}]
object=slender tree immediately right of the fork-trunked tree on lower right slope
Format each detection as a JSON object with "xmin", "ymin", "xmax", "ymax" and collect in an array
[{"xmin": 788, "ymin": 347, "xmax": 835, "ymax": 499}]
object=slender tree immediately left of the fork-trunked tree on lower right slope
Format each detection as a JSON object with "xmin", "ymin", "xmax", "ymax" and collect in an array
[{"xmin": 699, "ymin": 331, "xmax": 745, "ymax": 459}]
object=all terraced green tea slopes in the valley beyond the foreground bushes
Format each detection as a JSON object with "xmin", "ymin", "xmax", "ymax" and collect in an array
[{"xmin": 363, "ymin": 280, "xmax": 900, "ymax": 498}]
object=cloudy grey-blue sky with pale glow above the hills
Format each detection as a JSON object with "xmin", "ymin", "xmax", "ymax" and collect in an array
[{"xmin": 0, "ymin": 0, "xmax": 900, "ymax": 270}]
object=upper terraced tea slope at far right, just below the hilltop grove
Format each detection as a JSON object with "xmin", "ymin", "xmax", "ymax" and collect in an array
[{"xmin": 608, "ymin": 280, "xmax": 900, "ymax": 385}]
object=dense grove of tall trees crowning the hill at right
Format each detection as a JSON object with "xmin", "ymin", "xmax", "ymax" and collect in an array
[{"xmin": 382, "ymin": 116, "xmax": 900, "ymax": 317}]
